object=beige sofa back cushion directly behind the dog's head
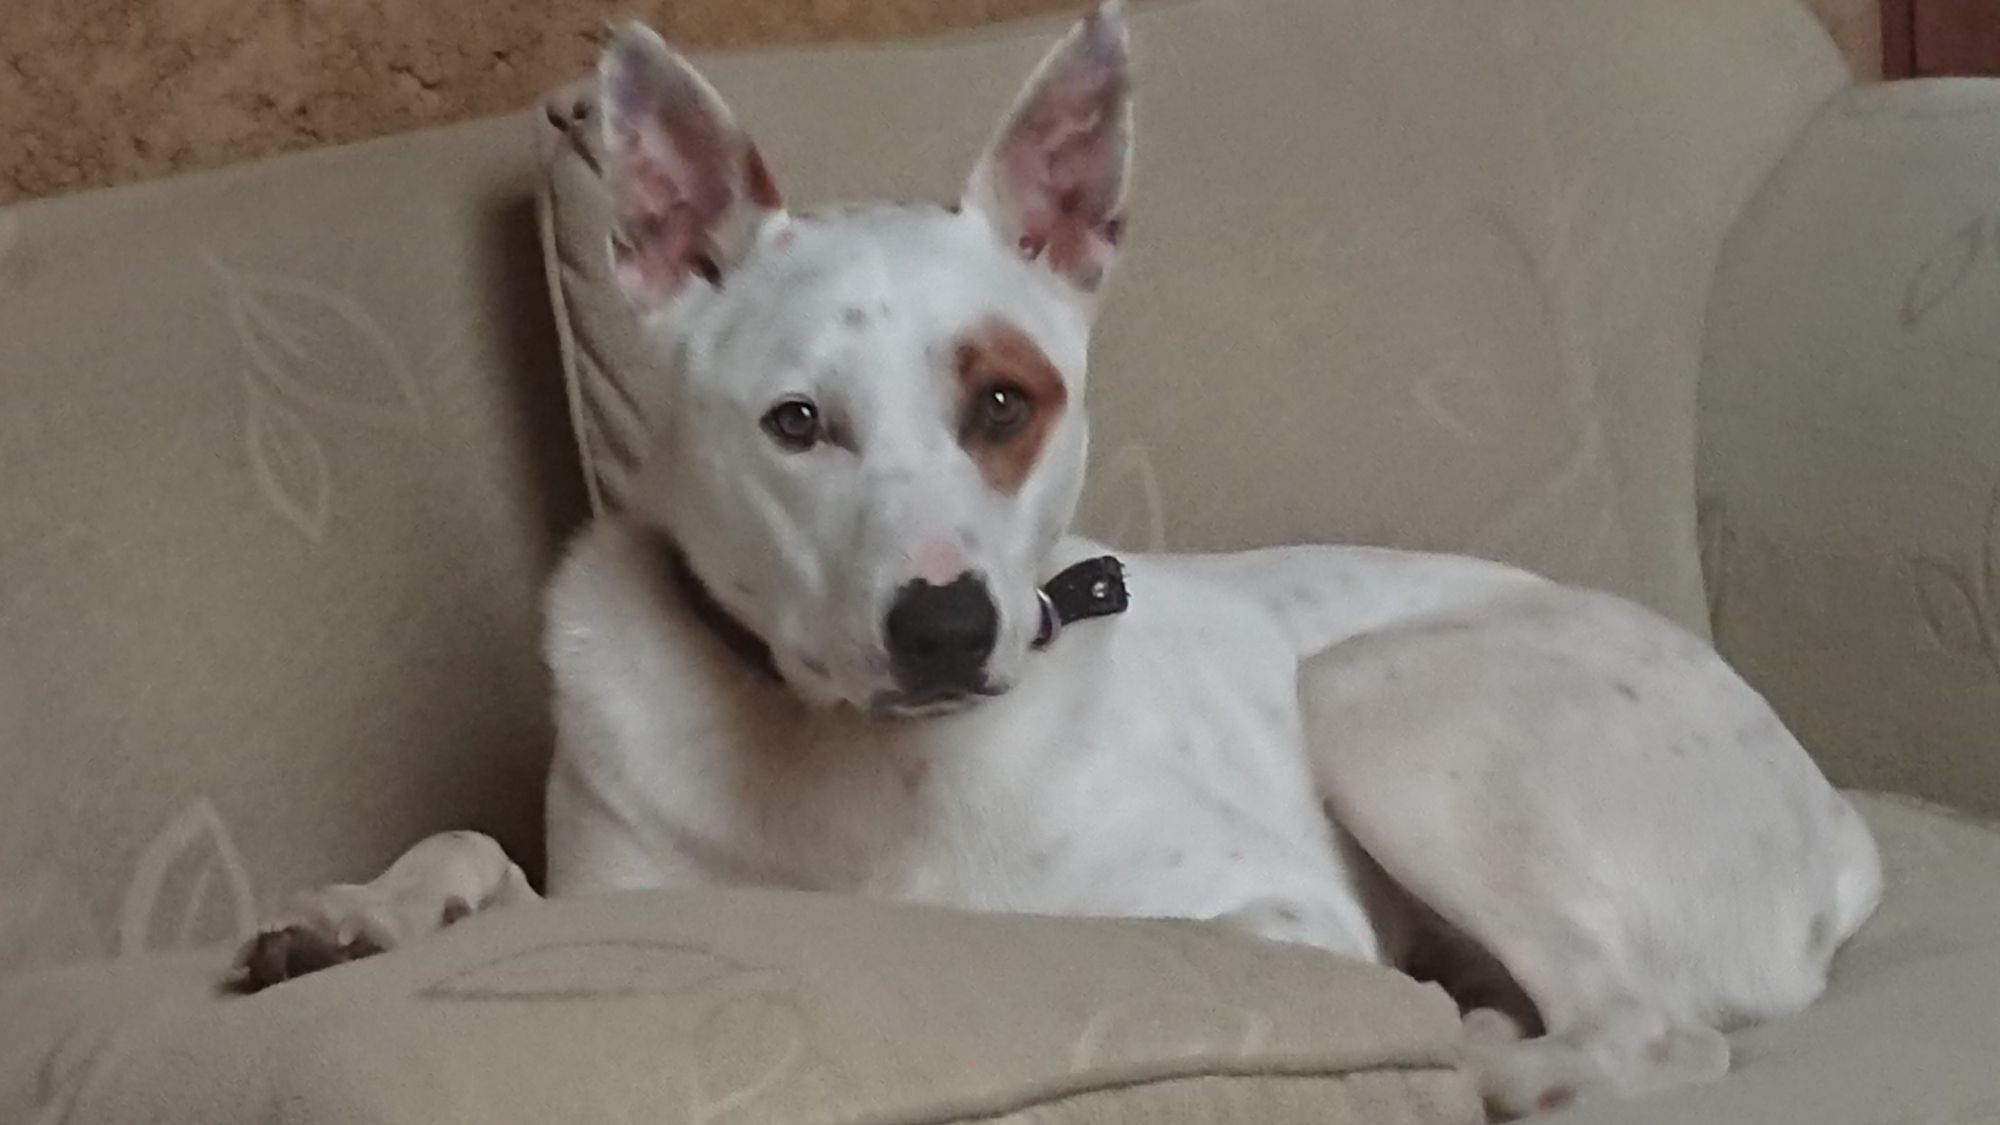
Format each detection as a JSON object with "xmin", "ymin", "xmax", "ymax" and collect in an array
[{"xmin": 544, "ymin": 0, "xmax": 1844, "ymax": 629}]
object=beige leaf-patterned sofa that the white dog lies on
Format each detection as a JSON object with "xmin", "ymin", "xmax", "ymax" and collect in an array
[{"xmin": 0, "ymin": 0, "xmax": 2000, "ymax": 1125}]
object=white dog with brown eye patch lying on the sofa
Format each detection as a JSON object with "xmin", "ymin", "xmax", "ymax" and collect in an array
[{"xmin": 230, "ymin": 6, "xmax": 1882, "ymax": 1113}]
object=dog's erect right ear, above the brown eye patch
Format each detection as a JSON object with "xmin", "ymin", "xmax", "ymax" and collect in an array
[{"xmin": 964, "ymin": 0, "xmax": 1132, "ymax": 292}]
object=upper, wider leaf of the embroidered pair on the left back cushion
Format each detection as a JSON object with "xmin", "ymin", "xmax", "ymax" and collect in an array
[{"xmin": 208, "ymin": 256, "xmax": 426, "ymax": 432}]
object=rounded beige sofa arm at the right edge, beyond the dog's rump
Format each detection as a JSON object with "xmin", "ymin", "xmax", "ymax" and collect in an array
[{"xmin": 1700, "ymin": 80, "xmax": 2000, "ymax": 813}]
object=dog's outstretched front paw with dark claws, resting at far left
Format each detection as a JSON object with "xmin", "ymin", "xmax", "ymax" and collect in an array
[{"xmin": 234, "ymin": 833, "xmax": 540, "ymax": 991}]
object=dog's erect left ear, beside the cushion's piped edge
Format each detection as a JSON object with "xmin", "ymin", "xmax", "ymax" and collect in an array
[{"xmin": 598, "ymin": 24, "xmax": 782, "ymax": 308}]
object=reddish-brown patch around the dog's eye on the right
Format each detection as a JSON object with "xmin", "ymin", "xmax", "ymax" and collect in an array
[{"xmin": 954, "ymin": 318, "xmax": 1070, "ymax": 494}]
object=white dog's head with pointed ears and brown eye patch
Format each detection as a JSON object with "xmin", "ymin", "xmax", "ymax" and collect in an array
[{"xmin": 600, "ymin": 6, "xmax": 1132, "ymax": 713}]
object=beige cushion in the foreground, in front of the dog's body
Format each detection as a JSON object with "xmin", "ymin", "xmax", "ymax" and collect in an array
[{"xmin": 0, "ymin": 893, "xmax": 1480, "ymax": 1125}]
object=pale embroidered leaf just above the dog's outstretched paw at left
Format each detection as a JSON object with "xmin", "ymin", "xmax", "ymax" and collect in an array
[{"xmin": 118, "ymin": 799, "xmax": 256, "ymax": 957}]
